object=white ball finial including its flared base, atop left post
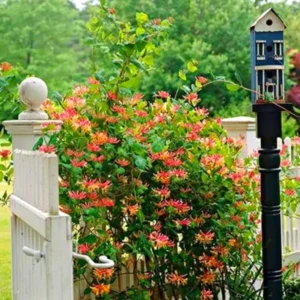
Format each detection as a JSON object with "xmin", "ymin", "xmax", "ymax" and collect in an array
[{"xmin": 19, "ymin": 77, "xmax": 48, "ymax": 120}]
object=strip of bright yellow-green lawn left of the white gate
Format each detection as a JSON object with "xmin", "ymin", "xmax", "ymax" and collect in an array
[{"xmin": 0, "ymin": 203, "xmax": 11, "ymax": 300}]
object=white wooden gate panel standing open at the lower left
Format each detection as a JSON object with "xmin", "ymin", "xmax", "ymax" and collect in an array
[{"xmin": 10, "ymin": 150, "xmax": 73, "ymax": 300}]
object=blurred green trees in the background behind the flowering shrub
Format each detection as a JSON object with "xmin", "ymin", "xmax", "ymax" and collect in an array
[{"xmin": 0, "ymin": 0, "xmax": 300, "ymax": 135}]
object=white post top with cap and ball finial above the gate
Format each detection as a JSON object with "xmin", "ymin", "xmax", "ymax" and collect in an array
[{"xmin": 3, "ymin": 77, "xmax": 61, "ymax": 150}]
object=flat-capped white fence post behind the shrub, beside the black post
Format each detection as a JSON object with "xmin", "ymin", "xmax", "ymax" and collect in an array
[{"xmin": 222, "ymin": 117, "xmax": 259, "ymax": 158}]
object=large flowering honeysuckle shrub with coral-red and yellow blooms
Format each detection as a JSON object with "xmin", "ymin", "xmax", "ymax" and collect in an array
[{"xmin": 36, "ymin": 4, "xmax": 261, "ymax": 299}]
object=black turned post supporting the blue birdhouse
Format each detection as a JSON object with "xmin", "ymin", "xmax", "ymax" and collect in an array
[{"xmin": 253, "ymin": 104, "xmax": 290, "ymax": 300}]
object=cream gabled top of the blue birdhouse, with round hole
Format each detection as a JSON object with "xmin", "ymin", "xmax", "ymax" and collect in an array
[{"xmin": 250, "ymin": 8, "xmax": 286, "ymax": 31}]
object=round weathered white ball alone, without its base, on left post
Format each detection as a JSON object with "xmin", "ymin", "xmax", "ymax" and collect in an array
[{"xmin": 19, "ymin": 77, "xmax": 48, "ymax": 110}]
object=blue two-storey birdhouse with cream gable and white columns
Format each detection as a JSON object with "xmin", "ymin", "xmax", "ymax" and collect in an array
[{"xmin": 250, "ymin": 8, "xmax": 286, "ymax": 103}]
